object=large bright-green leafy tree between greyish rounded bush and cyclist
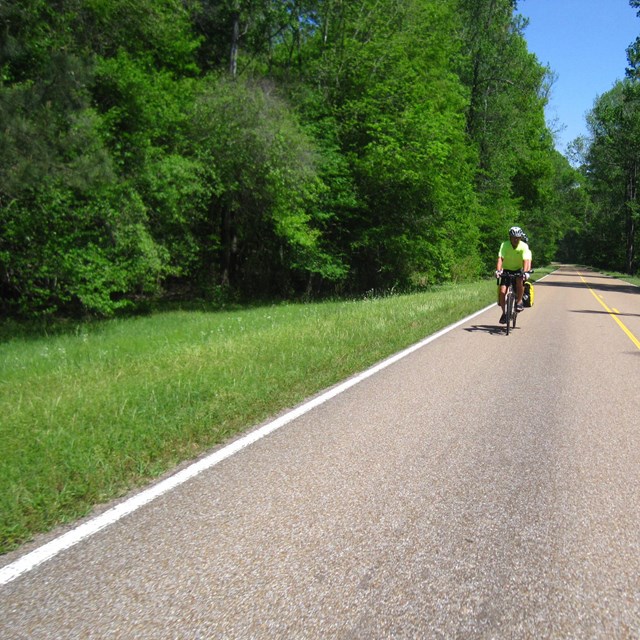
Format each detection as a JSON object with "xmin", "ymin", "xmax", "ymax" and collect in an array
[{"xmin": 273, "ymin": 0, "xmax": 479, "ymax": 290}]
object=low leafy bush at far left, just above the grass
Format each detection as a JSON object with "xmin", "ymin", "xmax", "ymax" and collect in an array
[{"xmin": 0, "ymin": 184, "xmax": 165, "ymax": 315}]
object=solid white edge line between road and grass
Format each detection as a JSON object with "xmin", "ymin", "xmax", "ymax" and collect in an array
[{"xmin": 0, "ymin": 303, "xmax": 495, "ymax": 586}]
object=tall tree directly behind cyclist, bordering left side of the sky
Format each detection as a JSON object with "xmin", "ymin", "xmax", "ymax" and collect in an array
[{"xmin": 459, "ymin": 0, "xmax": 554, "ymax": 267}]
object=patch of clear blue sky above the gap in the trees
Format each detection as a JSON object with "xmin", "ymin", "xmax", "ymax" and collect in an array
[{"xmin": 518, "ymin": 0, "xmax": 640, "ymax": 152}]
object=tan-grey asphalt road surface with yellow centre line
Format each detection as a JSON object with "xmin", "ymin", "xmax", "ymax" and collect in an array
[{"xmin": 0, "ymin": 268, "xmax": 640, "ymax": 640}]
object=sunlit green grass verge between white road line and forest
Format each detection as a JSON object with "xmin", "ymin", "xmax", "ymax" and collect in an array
[{"xmin": 0, "ymin": 270, "xmax": 545, "ymax": 553}]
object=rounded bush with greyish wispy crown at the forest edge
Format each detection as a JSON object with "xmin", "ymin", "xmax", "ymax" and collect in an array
[{"xmin": 186, "ymin": 78, "xmax": 340, "ymax": 291}]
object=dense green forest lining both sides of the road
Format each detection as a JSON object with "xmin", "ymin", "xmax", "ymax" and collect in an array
[{"xmin": 0, "ymin": 0, "xmax": 640, "ymax": 317}]
